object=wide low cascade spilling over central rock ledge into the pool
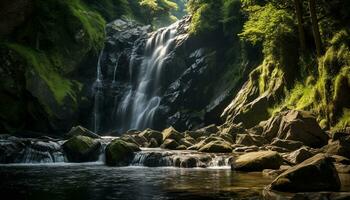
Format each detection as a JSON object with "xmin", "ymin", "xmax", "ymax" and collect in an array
[{"xmin": 131, "ymin": 149, "xmax": 233, "ymax": 168}]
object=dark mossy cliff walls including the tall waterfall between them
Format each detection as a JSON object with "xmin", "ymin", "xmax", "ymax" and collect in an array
[{"xmin": 0, "ymin": 0, "xmax": 350, "ymax": 134}]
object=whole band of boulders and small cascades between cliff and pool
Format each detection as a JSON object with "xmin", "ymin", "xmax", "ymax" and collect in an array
[{"xmin": 0, "ymin": 110, "xmax": 350, "ymax": 199}]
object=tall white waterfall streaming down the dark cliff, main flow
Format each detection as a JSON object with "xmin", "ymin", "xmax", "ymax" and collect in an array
[{"xmin": 117, "ymin": 23, "xmax": 178, "ymax": 131}]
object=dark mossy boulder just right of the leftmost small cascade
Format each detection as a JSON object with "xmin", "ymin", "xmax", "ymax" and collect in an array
[{"xmin": 63, "ymin": 135, "xmax": 101, "ymax": 162}]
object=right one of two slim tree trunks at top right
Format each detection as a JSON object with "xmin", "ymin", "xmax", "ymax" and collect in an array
[{"xmin": 309, "ymin": 0, "xmax": 322, "ymax": 57}]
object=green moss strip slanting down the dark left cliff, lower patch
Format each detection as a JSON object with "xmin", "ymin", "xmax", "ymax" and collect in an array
[{"xmin": 8, "ymin": 44, "xmax": 81, "ymax": 108}]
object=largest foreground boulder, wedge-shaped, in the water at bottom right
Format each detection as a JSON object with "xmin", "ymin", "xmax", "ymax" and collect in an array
[{"xmin": 270, "ymin": 154, "xmax": 340, "ymax": 192}]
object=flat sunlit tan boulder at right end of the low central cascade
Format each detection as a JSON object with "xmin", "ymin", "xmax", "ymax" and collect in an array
[{"xmin": 231, "ymin": 151, "xmax": 283, "ymax": 171}]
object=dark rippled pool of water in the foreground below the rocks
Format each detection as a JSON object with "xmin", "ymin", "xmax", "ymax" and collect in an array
[{"xmin": 0, "ymin": 164, "xmax": 350, "ymax": 200}]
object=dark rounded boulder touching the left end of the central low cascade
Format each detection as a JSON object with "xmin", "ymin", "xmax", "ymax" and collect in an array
[{"xmin": 105, "ymin": 139, "xmax": 141, "ymax": 166}]
